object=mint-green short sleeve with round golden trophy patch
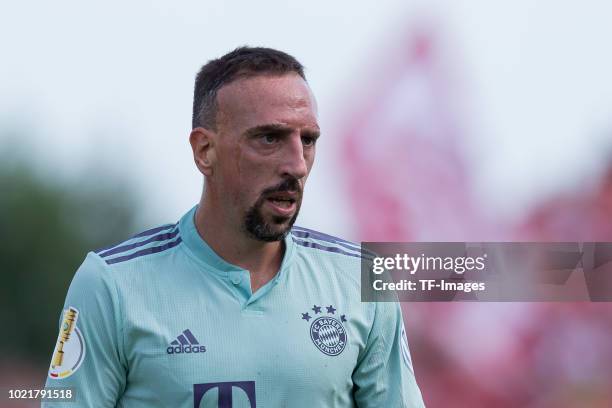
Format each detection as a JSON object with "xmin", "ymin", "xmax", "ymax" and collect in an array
[{"xmin": 42, "ymin": 253, "xmax": 126, "ymax": 407}]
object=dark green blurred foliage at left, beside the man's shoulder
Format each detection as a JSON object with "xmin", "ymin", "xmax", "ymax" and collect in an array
[{"xmin": 0, "ymin": 156, "xmax": 140, "ymax": 366}]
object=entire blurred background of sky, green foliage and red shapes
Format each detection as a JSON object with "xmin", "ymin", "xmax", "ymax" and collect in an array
[{"xmin": 0, "ymin": 0, "xmax": 612, "ymax": 407}]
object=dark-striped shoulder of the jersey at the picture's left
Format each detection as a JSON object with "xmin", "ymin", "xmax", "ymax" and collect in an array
[{"xmin": 90, "ymin": 223, "xmax": 182, "ymax": 265}]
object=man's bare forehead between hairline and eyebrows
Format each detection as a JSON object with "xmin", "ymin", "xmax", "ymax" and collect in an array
[{"xmin": 217, "ymin": 74, "xmax": 318, "ymax": 131}]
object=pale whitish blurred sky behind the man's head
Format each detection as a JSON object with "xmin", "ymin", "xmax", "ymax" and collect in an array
[{"xmin": 0, "ymin": 0, "xmax": 612, "ymax": 238}]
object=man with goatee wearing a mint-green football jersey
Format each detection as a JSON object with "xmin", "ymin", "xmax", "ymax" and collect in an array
[{"xmin": 47, "ymin": 47, "xmax": 423, "ymax": 408}]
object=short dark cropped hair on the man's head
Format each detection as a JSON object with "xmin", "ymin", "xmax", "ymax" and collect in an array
[{"xmin": 191, "ymin": 47, "xmax": 306, "ymax": 130}]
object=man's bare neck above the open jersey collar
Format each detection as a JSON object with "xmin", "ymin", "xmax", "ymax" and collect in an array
[{"xmin": 195, "ymin": 196, "xmax": 284, "ymax": 292}]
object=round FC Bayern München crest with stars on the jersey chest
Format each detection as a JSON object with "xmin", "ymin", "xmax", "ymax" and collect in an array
[{"xmin": 302, "ymin": 305, "xmax": 346, "ymax": 356}]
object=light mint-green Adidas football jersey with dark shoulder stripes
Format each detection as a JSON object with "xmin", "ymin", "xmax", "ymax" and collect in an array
[{"xmin": 44, "ymin": 208, "xmax": 423, "ymax": 408}]
